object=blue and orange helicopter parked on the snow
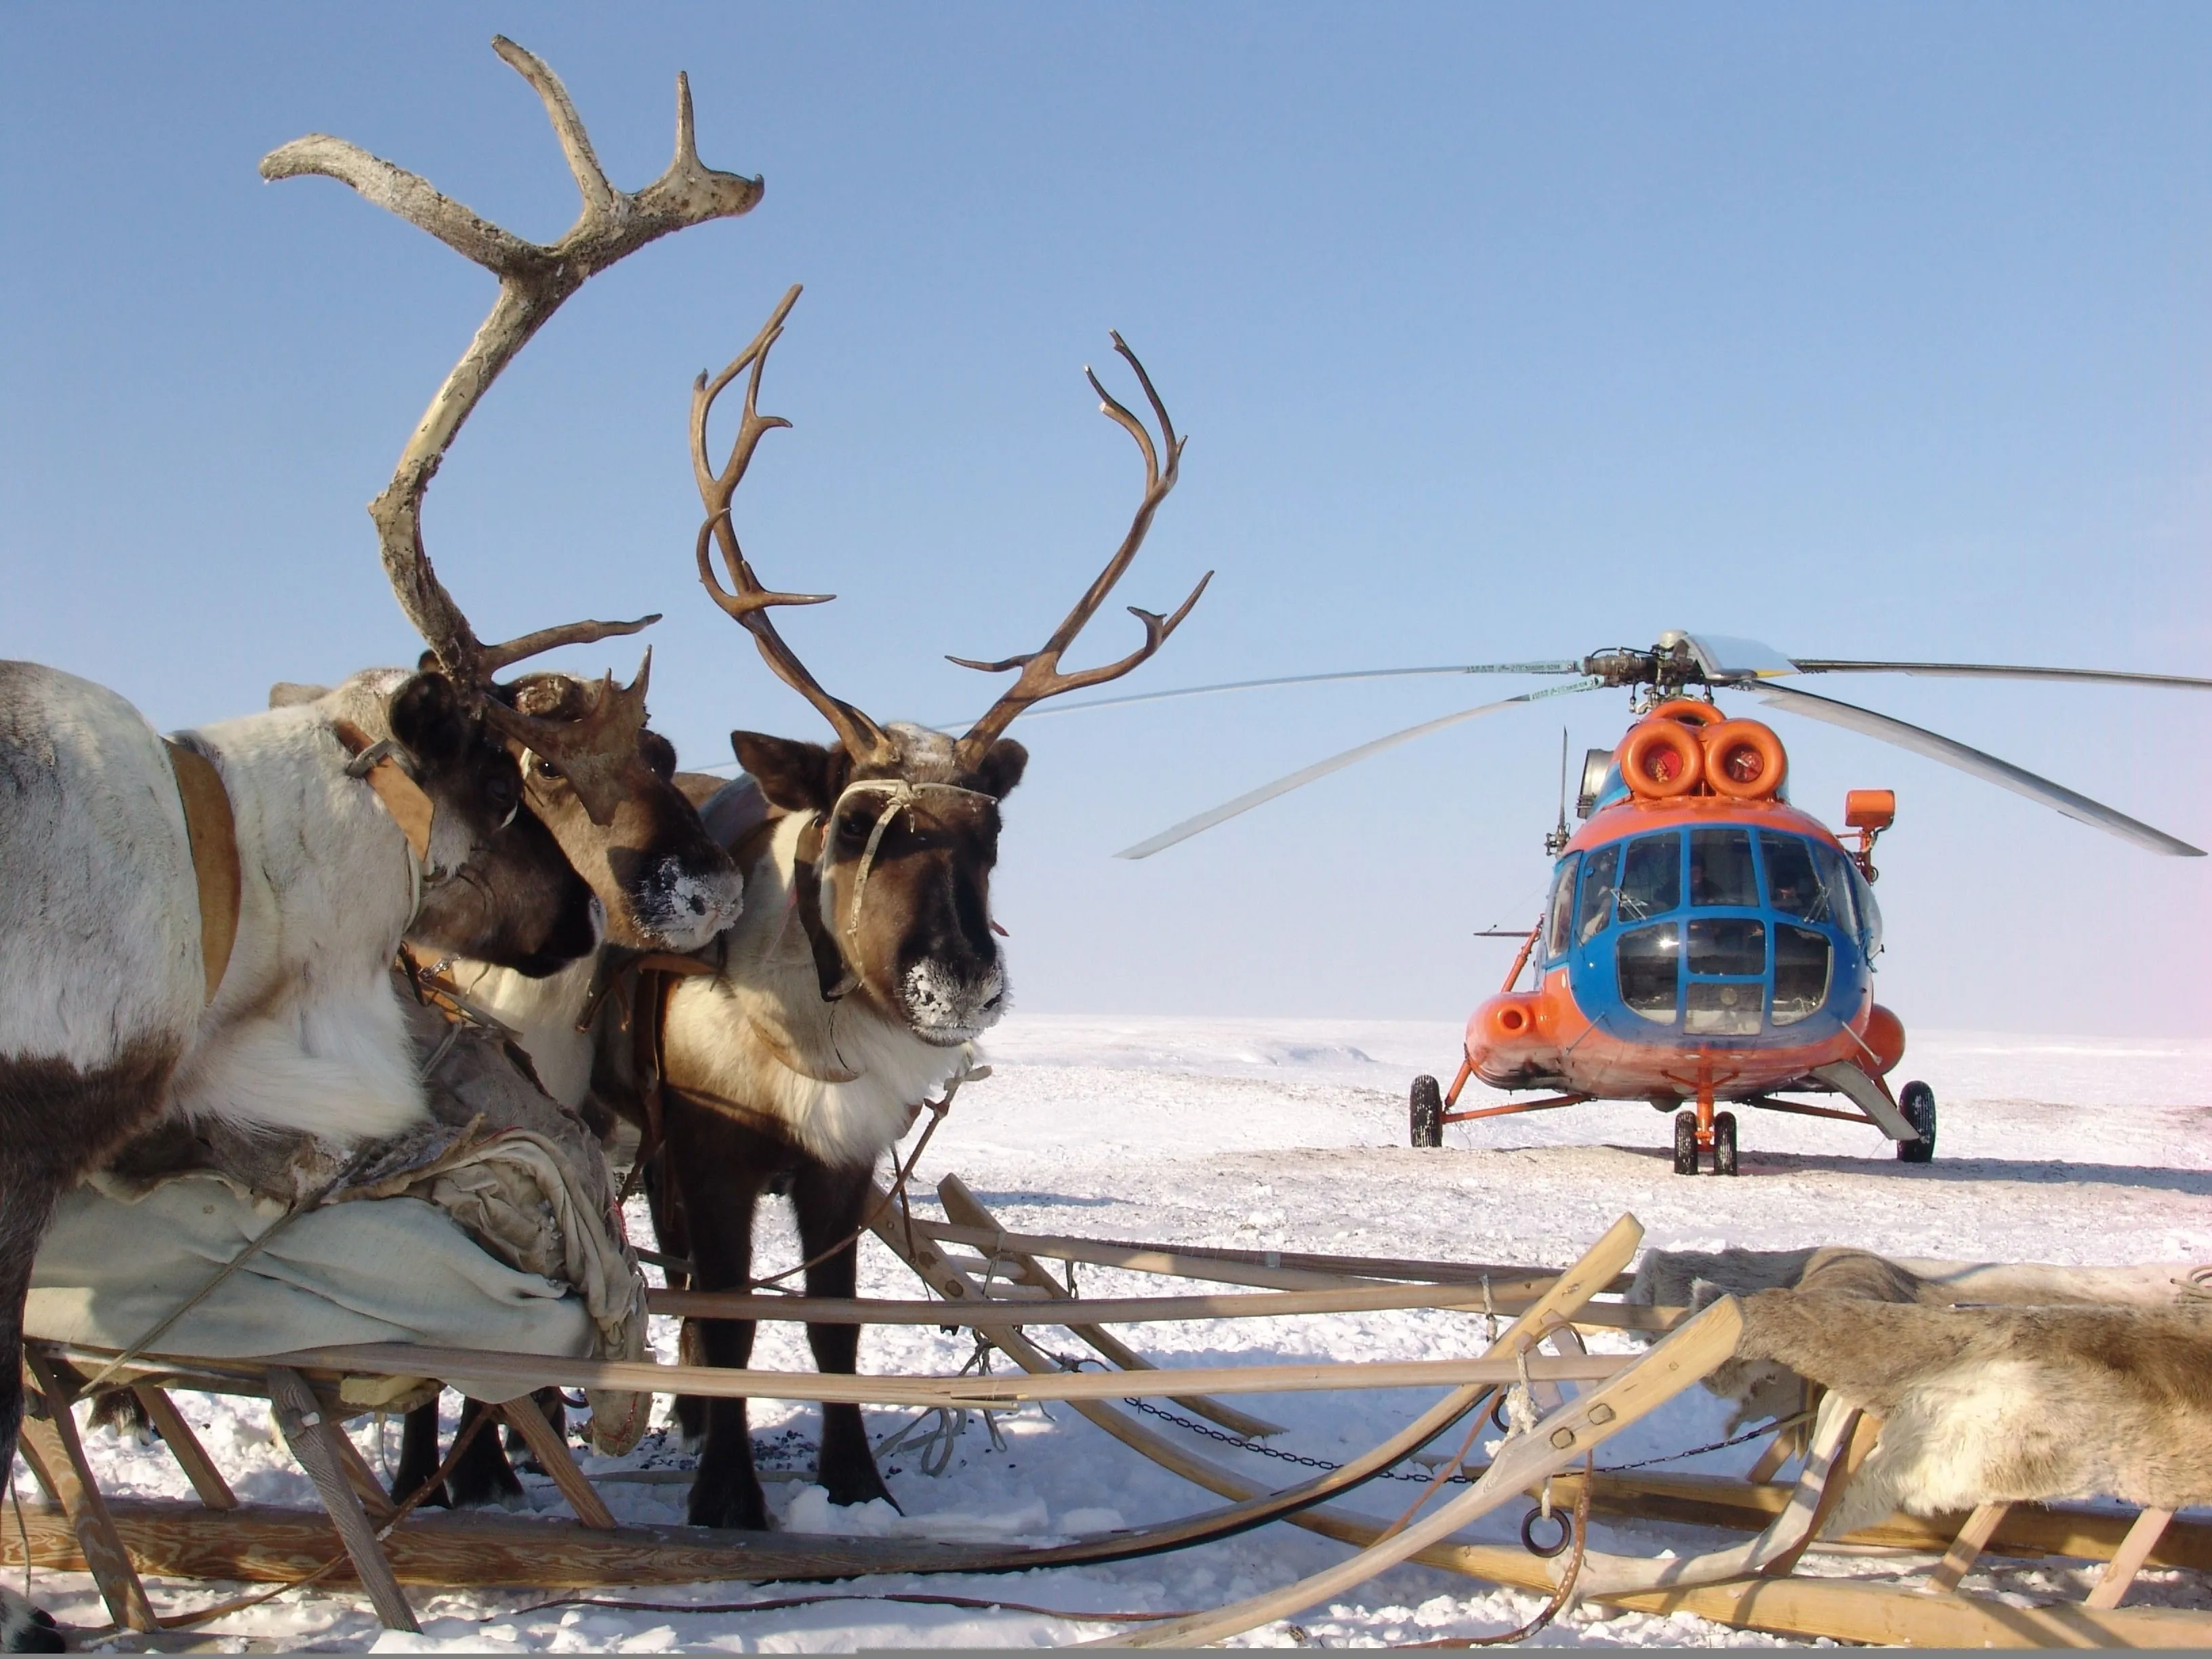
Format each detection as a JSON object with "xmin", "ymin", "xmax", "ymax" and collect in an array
[{"xmin": 1097, "ymin": 633, "xmax": 2212, "ymax": 1174}]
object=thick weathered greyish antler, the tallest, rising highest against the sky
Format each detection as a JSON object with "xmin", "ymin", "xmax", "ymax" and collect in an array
[{"xmin": 261, "ymin": 35, "xmax": 763, "ymax": 819}]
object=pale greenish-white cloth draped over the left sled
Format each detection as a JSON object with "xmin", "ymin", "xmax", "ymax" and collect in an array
[{"xmin": 24, "ymin": 1174, "xmax": 595, "ymax": 1400}]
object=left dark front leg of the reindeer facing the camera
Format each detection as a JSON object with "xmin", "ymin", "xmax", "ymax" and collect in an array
[{"xmin": 665, "ymin": 1101, "xmax": 781, "ymax": 1533}]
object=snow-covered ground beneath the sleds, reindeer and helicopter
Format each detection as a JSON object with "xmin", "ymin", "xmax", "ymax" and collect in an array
[{"xmin": 21, "ymin": 1015, "xmax": 2212, "ymax": 1652}]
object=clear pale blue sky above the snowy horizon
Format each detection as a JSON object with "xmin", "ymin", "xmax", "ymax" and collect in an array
[{"xmin": 0, "ymin": 2, "xmax": 2212, "ymax": 1040}]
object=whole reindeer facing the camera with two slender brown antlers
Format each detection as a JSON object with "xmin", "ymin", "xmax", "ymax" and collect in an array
[{"xmin": 651, "ymin": 287, "xmax": 1212, "ymax": 1526}]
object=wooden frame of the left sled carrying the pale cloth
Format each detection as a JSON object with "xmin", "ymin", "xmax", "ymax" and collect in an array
[{"xmin": 0, "ymin": 1176, "xmax": 1639, "ymax": 1633}]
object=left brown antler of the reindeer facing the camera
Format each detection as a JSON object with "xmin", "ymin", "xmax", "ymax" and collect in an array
[{"xmin": 690, "ymin": 285, "xmax": 894, "ymax": 763}]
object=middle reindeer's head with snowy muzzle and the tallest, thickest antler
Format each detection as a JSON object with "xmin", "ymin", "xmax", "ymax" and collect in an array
[{"xmin": 261, "ymin": 35, "xmax": 761, "ymax": 949}]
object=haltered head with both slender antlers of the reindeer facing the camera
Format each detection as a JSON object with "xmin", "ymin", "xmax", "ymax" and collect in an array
[{"xmin": 693, "ymin": 287, "xmax": 1212, "ymax": 1046}]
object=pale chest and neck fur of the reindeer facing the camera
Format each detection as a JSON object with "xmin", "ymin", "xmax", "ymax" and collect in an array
[{"xmin": 663, "ymin": 812, "xmax": 960, "ymax": 1168}]
